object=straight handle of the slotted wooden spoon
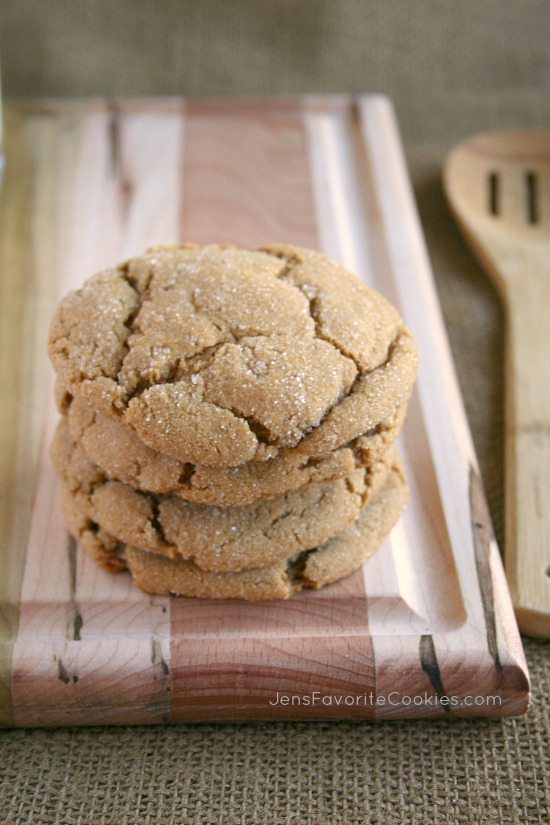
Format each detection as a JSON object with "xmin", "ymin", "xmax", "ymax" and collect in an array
[{"xmin": 503, "ymin": 270, "xmax": 550, "ymax": 637}]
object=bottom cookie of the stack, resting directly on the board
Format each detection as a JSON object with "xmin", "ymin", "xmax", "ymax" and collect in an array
[{"xmin": 64, "ymin": 458, "xmax": 408, "ymax": 600}]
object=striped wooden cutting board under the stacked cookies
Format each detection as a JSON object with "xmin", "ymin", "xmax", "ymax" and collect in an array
[{"xmin": 0, "ymin": 97, "xmax": 529, "ymax": 726}]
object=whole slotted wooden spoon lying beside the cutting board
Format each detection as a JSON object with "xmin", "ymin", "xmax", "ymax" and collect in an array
[{"xmin": 443, "ymin": 132, "xmax": 550, "ymax": 638}]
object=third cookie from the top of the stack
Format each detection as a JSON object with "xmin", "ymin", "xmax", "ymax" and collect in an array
[{"xmin": 51, "ymin": 420, "xmax": 399, "ymax": 572}]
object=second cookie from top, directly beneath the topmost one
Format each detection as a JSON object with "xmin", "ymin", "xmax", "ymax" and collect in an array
[{"xmin": 63, "ymin": 391, "xmax": 406, "ymax": 506}]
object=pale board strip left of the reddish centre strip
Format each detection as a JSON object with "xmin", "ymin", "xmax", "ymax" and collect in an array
[{"xmin": 12, "ymin": 102, "xmax": 183, "ymax": 724}]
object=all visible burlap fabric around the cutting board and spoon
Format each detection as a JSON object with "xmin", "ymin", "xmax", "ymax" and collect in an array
[{"xmin": 0, "ymin": 0, "xmax": 550, "ymax": 825}]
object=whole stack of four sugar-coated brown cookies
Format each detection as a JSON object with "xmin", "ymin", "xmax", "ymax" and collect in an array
[{"xmin": 49, "ymin": 245, "xmax": 417, "ymax": 599}]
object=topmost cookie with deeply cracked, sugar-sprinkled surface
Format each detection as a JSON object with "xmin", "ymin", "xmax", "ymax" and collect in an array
[{"xmin": 49, "ymin": 245, "xmax": 416, "ymax": 467}]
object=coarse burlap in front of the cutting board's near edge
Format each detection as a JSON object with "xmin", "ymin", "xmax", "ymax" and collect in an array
[{"xmin": 0, "ymin": 641, "xmax": 550, "ymax": 825}]
